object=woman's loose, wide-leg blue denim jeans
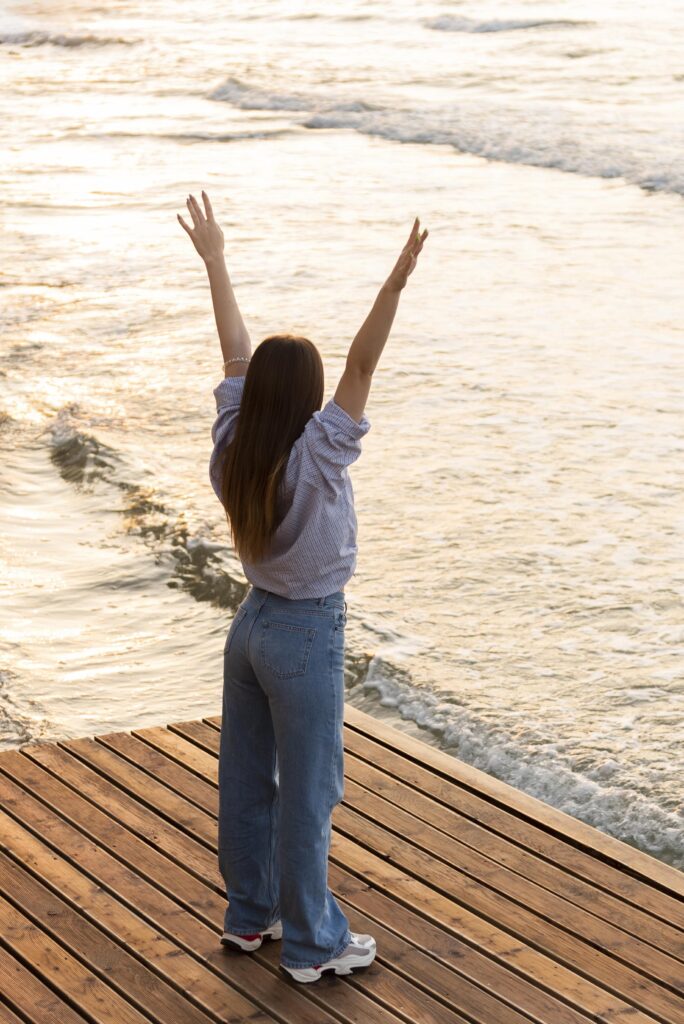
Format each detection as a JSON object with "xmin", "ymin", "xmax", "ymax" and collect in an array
[{"xmin": 218, "ymin": 586, "xmax": 351, "ymax": 967}]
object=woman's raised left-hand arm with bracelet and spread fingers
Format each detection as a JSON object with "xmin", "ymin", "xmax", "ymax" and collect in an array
[{"xmin": 176, "ymin": 191, "xmax": 252, "ymax": 377}]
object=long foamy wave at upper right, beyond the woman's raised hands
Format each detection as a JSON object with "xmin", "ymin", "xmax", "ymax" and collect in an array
[{"xmin": 210, "ymin": 78, "xmax": 684, "ymax": 196}]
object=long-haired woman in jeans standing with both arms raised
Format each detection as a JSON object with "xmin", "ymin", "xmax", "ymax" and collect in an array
[{"xmin": 178, "ymin": 191, "xmax": 428, "ymax": 982}]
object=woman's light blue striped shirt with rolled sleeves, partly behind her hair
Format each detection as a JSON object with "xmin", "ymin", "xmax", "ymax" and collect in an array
[{"xmin": 209, "ymin": 376, "xmax": 371, "ymax": 599}]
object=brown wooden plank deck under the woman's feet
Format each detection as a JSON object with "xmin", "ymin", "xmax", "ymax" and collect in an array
[{"xmin": 0, "ymin": 706, "xmax": 684, "ymax": 1024}]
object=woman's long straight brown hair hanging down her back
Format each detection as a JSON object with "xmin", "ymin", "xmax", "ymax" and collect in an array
[{"xmin": 221, "ymin": 334, "xmax": 324, "ymax": 562}]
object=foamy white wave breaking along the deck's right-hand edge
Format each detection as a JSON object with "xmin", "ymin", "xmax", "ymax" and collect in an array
[{"xmin": 356, "ymin": 658, "xmax": 684, "ymax": 868}]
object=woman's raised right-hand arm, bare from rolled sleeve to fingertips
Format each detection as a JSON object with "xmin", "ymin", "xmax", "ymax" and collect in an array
[{"xmin": 334, "ymin": 217, "xmax": 428, "ymax": 423}]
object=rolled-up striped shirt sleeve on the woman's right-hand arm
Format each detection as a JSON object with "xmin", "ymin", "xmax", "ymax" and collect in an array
[{"xmin": 302, "ymin": 398, "xmax": 371, "ymax": 488}]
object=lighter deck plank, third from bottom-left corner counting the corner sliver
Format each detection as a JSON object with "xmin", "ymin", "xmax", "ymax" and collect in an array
[{"xmin": 0, "ymin": 896, "xmax": 149, "ymax": 1024}]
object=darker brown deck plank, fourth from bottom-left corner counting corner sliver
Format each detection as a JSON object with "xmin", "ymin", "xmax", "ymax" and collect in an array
[{"xmin": 0, "ymin": 853, "xmax": 212, "ymax": 1024}]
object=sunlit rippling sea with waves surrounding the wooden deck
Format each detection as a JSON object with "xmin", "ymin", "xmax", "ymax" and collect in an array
[{"xmin": 0, "ymin": 0, "xmax": 684, "ymax": 868}]
